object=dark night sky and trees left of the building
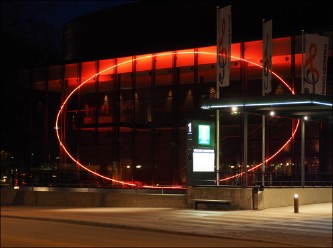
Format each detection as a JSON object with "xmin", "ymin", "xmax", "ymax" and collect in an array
[{"xmin": 0, "ymin": 0, "xmax": 133, "ymax": 160}]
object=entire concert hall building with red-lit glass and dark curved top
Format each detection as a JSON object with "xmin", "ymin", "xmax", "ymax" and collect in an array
[{"xmin": 19, "ymin": 1, "xmax": 332, "ymax": 187}]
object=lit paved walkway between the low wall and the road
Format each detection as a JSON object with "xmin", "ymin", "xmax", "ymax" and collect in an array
[{"xmin": 1, "ymin": 203, "xmax": 332, "ymax": 247}]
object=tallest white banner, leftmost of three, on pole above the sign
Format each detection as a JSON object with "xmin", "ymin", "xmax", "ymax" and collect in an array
[{"xmin": 217, "ymin": 5, "xmax": 231, "ymax": 87}]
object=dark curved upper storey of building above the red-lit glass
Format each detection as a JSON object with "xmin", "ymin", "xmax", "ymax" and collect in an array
[{"xmin": 63, "ymin": 0, "xmax": 332, "ymax": 62}]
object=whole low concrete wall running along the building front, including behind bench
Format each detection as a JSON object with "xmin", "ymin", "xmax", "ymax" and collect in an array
[{"xmin": 1, "ymin": 187, "xmax": 332, "ymax": 210}]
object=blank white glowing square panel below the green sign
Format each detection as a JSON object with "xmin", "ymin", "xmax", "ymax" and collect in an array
[{"xmin": 193, "ymin": 149, "xmax": 215, "ymax": 172}]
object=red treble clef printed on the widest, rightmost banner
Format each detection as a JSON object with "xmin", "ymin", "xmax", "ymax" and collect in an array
[{"xmin": 304, "ymin": 43, "xmax": 319, "ymax": 93}]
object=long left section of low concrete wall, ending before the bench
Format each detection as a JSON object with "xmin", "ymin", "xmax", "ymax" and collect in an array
[{"xmin": 1, "ymin": 190, "xmax": 187, "ymax": 208}]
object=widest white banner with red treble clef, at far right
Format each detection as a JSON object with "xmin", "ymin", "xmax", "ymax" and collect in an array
[{"xmin": 303, "ymin": 34, "xmax": 328, "ymax": 95}]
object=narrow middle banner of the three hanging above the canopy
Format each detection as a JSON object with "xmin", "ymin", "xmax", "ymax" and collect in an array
[{"xmin": 262, "ymin": 20, "xmax": 272, "ymax": 95}]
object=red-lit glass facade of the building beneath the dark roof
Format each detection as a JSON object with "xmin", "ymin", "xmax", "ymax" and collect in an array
[{"xmin": 22, "ymin": 37, "xmax": 332, "ymax": 187}]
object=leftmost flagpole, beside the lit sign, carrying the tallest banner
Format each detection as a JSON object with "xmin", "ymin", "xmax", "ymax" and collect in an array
[{"xmin": 216, "ymin": 6, "xmax": 220, "ymax": 186}]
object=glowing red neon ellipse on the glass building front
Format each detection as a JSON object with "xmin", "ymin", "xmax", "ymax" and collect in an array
[{"xmin": 55, "ymin": 51, "xmax": 299, "ymax": 188}]
